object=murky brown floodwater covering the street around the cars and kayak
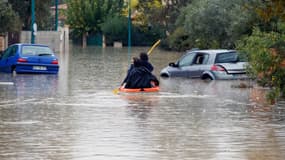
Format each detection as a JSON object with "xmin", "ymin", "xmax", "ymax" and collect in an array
[{"xmin": 0, "ymin": 46, "xmax": 285, "ymax": 160}]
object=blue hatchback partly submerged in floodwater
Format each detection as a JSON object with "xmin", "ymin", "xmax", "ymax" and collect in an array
[{"xmin": 0, "ymin": 43, "xmax": 59, "ymax": 74}]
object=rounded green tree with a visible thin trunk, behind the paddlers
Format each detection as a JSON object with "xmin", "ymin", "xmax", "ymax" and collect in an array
[{"xmin": 66, "ymin": 0, "xmax": 124, "ymax": 47}]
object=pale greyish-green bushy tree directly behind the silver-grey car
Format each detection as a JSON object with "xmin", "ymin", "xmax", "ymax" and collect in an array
[{"xmin": 176, "ymin": 0, "xmax": 254, "ymax": 48}]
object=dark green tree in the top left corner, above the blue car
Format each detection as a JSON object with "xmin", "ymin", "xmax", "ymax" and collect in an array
[{"xmin": 0, "ymin": 1, "xmax": 21, "ymax": 34}]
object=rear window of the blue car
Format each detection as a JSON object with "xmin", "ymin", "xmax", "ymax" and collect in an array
[{"xmin": 22, "ymin": 46, "xmax": 53, "ymax": 56}]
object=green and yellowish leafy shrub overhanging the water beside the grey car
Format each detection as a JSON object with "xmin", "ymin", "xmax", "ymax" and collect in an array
[{"xmin": 237, "ymin": 28, "xmax": 285, "ymax": 101}]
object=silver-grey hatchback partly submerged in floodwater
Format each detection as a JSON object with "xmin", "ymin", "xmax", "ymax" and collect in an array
[{"xmin": 160, "ymin": 49, "xmax": 248, "ymax": 80}]
